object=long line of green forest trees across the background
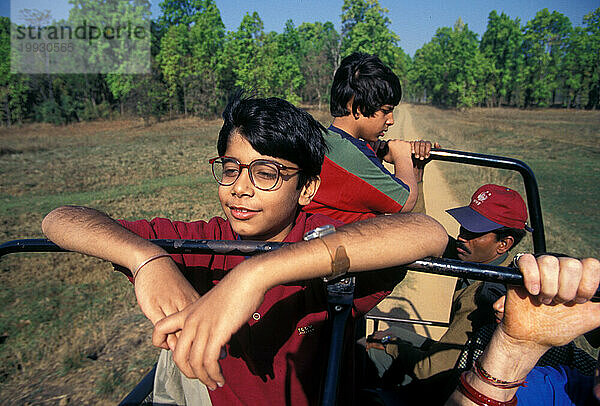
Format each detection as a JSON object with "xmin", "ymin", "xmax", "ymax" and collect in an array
[{"xmin": 0, "ymin": 0, "xmax": 600, "ymax": 126}]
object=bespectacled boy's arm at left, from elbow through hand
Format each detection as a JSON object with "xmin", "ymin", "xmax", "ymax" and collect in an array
[{"xmin": 42, "ymin": 206, "xmax": 200, "ymax": 338}]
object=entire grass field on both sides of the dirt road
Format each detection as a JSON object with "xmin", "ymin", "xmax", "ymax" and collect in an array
[{"xmin": 0, "ymin": 106, "xmax": 600, "ymax": 405}]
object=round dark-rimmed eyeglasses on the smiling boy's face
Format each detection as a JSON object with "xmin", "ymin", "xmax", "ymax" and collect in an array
[{"xmin": 208, "ymin": 156, "xmax": 300, "ymax": 190}]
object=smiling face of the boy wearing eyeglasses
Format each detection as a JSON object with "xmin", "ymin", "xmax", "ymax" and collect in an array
[{"xmin": 219, "ymin": 134, "xmax": 318, "ymax": 241}]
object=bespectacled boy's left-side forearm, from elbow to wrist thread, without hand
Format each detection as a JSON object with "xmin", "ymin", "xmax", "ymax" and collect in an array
[{"xmin": 42, "ymin": 206, "xmax": 165, "ymax": 269}]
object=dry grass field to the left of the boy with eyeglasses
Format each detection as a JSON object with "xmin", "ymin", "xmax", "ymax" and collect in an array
[{"xmin": 0, "ymin": 119, "xmax": 220, "ymax": 404}]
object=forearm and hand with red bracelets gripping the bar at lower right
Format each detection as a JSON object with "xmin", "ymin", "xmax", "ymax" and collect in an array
[{"xmin": 446, "ymin": 256, "xmax": 600, "ymax": 405}]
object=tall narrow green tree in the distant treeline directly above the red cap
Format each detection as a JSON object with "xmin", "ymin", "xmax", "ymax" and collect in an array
[{"xmin": 479, "ymin": 10, "xmax": 522, "ymax": 106}]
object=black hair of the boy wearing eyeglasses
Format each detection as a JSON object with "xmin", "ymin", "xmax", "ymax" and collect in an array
[{"xmin": 217, "ymin": 91, "xmax": 327, "ymax": 189}]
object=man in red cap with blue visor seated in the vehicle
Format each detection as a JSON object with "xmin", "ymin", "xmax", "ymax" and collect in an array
[{"xmin": 367, "ymin": 184, "xmax": 531, "ymax": 403}]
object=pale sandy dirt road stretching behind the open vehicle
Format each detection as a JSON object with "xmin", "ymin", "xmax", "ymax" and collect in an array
[{"xmin": 368, "ymin": 104, "xmax": 461, "ymax": 341}]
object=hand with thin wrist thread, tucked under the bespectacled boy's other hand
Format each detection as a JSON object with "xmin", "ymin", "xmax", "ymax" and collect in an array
[{"xmin": 134, "ymin": 257, "xmax": 200, "ymax": 349}]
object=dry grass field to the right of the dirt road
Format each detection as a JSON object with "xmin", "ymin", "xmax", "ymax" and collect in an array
[{"xmin": 410, "ymin": 105, "xmax": 600, "ymax": 257}]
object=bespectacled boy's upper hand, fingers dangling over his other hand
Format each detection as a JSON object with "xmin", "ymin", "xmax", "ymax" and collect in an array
[{"xmin": 152, "ymin": 261, "xmax": 265, "ymax": 390}]
